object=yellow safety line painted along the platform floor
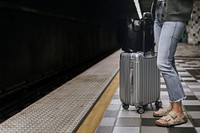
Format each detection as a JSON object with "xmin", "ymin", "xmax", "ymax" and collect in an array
[{"xmin": 77, "ymin": 73, "xmax": 119, "ymax": 133}]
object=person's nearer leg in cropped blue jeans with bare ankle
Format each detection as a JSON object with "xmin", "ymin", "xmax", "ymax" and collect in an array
[{"xmin": 157, "ymin": 22, "xmax": 188, "ymax": 123}]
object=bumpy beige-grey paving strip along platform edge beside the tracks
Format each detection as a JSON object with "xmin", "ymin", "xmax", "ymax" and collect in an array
[{"xmin": 0, "ymin": 51, "xmax": 120, "ymax": 133}]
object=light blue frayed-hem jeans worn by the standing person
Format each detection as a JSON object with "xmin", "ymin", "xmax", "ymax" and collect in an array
[{"xmin": 154, "ymin": 2, "xmax": 185, "ymax": 102}]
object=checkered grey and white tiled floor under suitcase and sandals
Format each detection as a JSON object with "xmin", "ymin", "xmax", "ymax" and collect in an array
[{"xmin": 78, "ymin": 44, "xmax": 200, "ymax": 133}]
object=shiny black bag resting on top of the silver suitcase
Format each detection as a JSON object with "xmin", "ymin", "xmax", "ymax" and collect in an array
[{"xmin": 121, "ymin": 12, "xmax": 155, "ymax": 53}]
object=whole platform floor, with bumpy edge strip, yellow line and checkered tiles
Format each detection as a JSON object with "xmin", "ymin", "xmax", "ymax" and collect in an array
[{"xmin": 0, "ymin": 44, "xmax": 200, "ymax": 133}]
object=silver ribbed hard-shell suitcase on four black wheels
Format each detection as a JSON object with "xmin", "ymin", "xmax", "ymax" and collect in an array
[{"xmin": 120, "ymin": 52, "xmax": 162, "ymax": 114}]
